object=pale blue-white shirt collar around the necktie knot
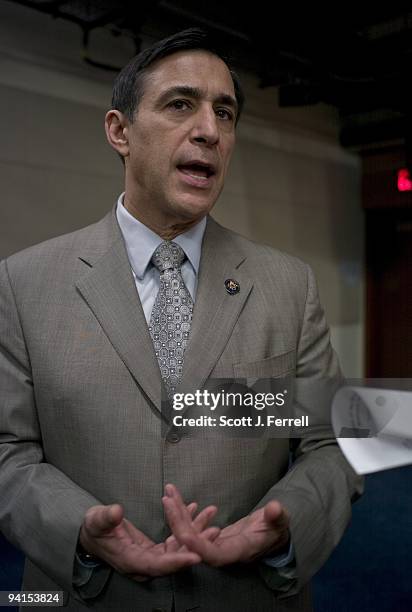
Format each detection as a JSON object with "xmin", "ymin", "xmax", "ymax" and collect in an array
[{"xmin": 116, "ymin": 193, "xmax": 206, "ymax": 280}]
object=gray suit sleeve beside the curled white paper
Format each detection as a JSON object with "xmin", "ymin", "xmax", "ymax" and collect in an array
[{"xmin": 254, "ymin": 268, "xmax": 363, "ymax": 596}]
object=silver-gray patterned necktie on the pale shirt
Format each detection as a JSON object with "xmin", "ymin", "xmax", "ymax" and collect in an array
[{"xmin": 149, "ymin": 241, "xmax": 193, "ymax": 397}]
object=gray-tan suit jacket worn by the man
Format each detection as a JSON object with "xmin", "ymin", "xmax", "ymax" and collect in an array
[{"xmin": 0, "ymin": 211, "xmax": 361, "ymax": 612}]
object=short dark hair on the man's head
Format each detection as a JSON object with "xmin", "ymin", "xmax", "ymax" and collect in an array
[{"xmin": 112, "ymin": 28, "xmax": 245, "ymax": 123}]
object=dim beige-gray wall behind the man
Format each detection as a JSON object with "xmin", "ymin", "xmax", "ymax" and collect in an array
[{"xmin": 0, "ymin": 3, "xmax": 363, "ymax": 376}]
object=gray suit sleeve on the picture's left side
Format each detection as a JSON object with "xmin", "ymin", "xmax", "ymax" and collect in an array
[{"xmin": 0, "ymin": 261, "xmax": 110, "ymax": 597}]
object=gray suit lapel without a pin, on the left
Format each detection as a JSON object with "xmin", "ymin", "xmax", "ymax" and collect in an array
[{"xmin": 76, "ymin": 212, "xmax": 162, "ymax": 410}]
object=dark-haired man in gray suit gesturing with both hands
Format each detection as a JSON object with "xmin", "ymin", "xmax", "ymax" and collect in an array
[{"xmin": 0, "ymin": 30, "xmax": 361, "ymax": 612}]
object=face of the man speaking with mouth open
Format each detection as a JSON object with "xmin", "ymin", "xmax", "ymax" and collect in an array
[{"xmin": 125, "ymin": 50, "xmax": 236, "ymax": 227}]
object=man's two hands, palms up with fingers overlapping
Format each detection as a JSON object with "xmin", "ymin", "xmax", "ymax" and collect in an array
[{"xmin": 80, "ymin": 484, "xmax": 289, "ymax": 581}]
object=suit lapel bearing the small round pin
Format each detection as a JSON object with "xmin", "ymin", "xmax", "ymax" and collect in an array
[{"xmin": 179, "ymin": 217, "xmax": 253, "ymax": 390}]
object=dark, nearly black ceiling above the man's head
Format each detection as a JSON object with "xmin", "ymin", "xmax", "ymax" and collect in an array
[{"xmin": 5, "ymin": 0, "xmax": 412, "ymax": 150}]
